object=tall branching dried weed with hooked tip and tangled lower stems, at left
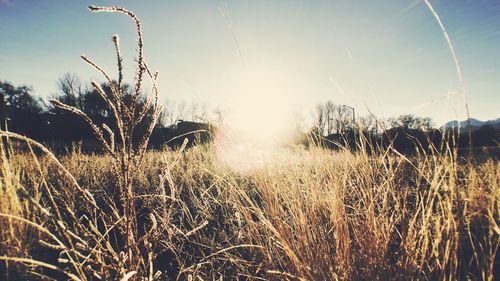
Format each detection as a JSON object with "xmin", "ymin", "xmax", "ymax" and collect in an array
[{"xmin": 0, "ymin": 5, "xmax": 168, "ymax": 280}]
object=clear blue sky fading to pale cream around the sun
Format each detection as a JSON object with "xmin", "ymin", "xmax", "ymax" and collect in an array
[{"xmin": 0, "ymin": 0, "xmax": 500, "ymax": 126}]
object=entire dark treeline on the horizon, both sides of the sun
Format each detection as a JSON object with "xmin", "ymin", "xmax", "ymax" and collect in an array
[{"xmin": 0, "ymin": 74, "xmax": 500, "ymax": 153}]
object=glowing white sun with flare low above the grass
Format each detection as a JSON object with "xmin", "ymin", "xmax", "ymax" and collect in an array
[{"xmin": 215, "ymin": 72, "xmax": 292, "ymax": 170}]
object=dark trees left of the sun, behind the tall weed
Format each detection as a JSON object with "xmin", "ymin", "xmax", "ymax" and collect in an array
[{"xmin": 0, "ymin": 74, "xmax": 214, "ymax": 151}]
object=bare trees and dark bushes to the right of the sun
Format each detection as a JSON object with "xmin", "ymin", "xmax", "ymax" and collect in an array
[{"xmin": 308, "ymin": 101, "xmax": 500, "ymax": 157}]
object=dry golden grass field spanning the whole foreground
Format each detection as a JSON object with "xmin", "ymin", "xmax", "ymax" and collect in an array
[{"xmin": 0, "ymin": 141, "xmax": 500, "ymax": 280}]
